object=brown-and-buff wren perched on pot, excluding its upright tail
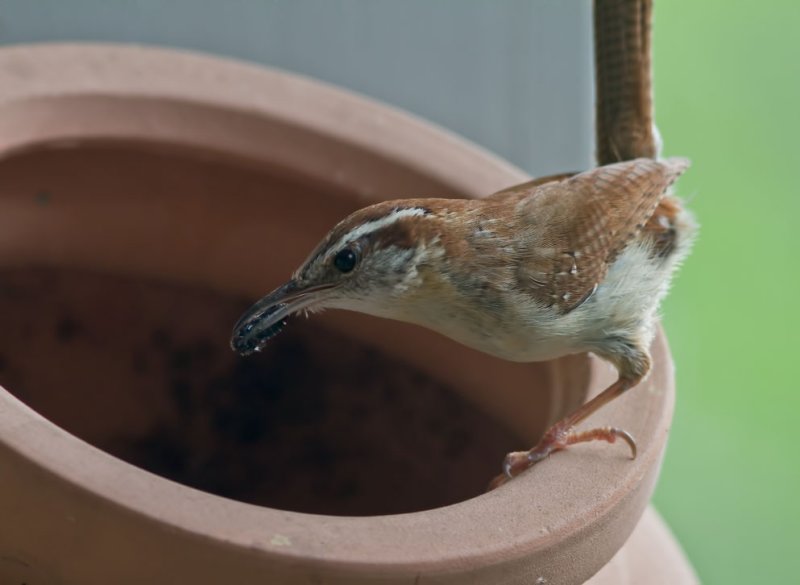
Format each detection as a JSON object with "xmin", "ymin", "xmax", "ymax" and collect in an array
[{"xmin": 231, "ymin": 158, "xmax": 695, "ymax": 486}]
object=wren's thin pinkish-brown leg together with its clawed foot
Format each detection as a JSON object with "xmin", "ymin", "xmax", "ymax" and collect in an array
[{"xmin": 489, "ymin": 346, "xmax": 650, "ymax": 490}]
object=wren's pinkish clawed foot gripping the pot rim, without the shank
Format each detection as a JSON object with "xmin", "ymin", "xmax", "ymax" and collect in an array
[{"xmin": 489, "ymin": 422, "xmax": 636, "ymax": 490}]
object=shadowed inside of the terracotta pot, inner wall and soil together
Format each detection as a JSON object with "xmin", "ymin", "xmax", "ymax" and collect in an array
[{"xmin": 0, "ymin": 142, "xmax": 588, "ymax": 515}]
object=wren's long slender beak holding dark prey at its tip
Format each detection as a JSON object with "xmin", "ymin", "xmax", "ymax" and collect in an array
[{"xmin": 231, "ymin": 279, "xmax": 332, "ymax": 356}]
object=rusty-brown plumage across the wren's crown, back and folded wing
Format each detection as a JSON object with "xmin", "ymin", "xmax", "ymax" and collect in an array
[{"xmin": 312, "ymin": 158, "xmax": 688, "ymax": 312}]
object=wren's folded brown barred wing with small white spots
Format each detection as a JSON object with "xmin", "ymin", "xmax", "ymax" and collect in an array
[{"xmin": 507, "ymin": 159, "xmax": 689, "ymax": 313}]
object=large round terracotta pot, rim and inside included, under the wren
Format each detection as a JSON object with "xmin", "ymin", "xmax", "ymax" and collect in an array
[{"xmin": 0, "ymin": 45, "xmax": 692, "ymax": 585}]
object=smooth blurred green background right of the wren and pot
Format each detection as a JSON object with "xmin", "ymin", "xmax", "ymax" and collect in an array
[{"xmin": 654, "ymin": 0, "xmax": 800, "ymax": 584}]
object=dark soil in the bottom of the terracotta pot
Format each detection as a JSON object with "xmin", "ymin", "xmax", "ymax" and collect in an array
[{"xmin": 0, "ymin": 269, "xmax": 514, "ymax": 515}]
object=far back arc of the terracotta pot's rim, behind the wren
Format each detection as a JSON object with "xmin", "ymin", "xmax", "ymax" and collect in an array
[{"xmin": 0, "ymin": 43, "xmax": 529, "ymax": 201}]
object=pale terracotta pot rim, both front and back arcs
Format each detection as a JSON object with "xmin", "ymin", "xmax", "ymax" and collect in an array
[{"xmin": 0, "ymin": 45, "xmax": 674, "ymax": 574}]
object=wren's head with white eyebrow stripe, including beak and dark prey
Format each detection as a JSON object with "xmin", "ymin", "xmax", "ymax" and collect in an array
[{"xmin": 231, "ymin": 200, "xmax": 435, "ymax": 355}]
